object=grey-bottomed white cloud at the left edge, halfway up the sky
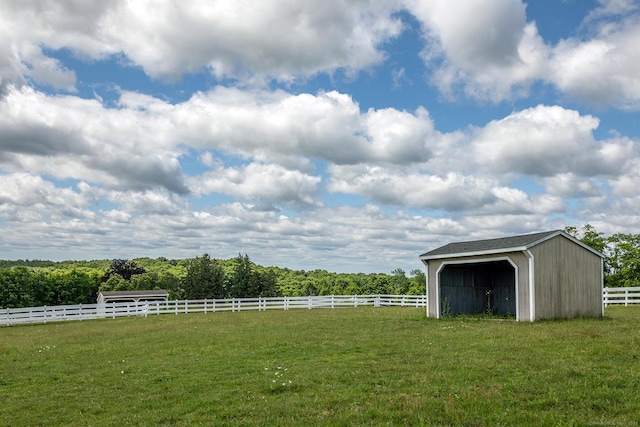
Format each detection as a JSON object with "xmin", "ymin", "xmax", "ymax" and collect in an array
[{"xmin": 0, "ymin": 88, "xmax": 187, "ymax": 194}]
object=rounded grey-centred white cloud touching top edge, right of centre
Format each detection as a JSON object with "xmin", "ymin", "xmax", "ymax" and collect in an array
[{"xmin": 407, "ymin": 0, "xmax": 547, "ymax": 102}]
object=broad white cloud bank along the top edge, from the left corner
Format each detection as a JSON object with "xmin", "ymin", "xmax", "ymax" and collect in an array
[{"xmin": 0, "ymin": 0, "xmax": 402, "ymax": 88}]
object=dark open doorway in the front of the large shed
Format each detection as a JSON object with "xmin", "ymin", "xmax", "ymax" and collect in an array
[{"xmin": 439, "ymin": 260, "xmax": 516, "ymax": 316}]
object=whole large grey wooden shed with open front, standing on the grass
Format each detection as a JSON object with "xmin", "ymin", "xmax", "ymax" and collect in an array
[{"xmin": 420, "ymin": 230, "xmax": 604, "ymax": 322}]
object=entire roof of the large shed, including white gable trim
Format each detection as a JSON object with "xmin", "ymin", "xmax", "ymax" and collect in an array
[{"xmin": 420, "ymin": 230, "xmax": 602, "ymax": 260}]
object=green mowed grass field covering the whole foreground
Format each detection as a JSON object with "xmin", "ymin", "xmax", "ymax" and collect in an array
[{"xmin": 0, "ymin": 307, "xmax": 640, "ymax": 426}]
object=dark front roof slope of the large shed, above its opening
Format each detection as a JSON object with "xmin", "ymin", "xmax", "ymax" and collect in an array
[{"xmin": 420, "ymin": 230, "xmax": 565, "ymax": 258}]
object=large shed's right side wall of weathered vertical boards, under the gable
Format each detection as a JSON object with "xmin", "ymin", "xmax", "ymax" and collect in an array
[{"xmin": 530, "ymin": 236, "xmax": 603, "ymax": 320}]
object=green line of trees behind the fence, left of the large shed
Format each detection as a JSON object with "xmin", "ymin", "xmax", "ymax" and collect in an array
[{"xmin": 0, "ymin": 253, "xmax": 425, "ymax": 308}]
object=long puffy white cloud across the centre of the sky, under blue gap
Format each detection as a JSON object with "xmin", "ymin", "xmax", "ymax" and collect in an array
[{"xmin": 174, "ymin": 88, "xmax": 437, "ymax": 169}]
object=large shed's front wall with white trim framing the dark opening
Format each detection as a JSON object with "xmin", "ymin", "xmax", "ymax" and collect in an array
[{"xmin": 427, "ymin": 252, "xmax": 530, "ymax": 321}]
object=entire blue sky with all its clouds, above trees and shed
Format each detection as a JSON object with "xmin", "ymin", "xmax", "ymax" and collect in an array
[{"xmin": 0, "ymin": 0, "xmax": 640, "ymax": 273}]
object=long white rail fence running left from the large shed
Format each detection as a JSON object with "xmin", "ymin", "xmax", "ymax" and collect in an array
[{"xmin": 0, "ymin": 295, "xmax": 427, "ymax": 325}]
